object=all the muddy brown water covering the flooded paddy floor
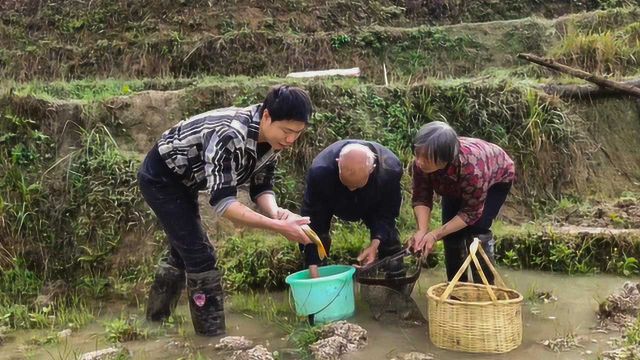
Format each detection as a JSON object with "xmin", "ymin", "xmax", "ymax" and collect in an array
[{"xmin": 0, "ymin": 269, "xmax": 637, "ymax": 360}]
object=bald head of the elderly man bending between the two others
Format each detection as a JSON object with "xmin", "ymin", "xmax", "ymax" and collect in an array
[{"xmin": 337, "ymin": 144, "xmax": 376, "ymax": 191}]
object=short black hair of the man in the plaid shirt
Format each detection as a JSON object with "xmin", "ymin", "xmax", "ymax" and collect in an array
[{"xmin": 260, "ymin": 85, "xmax": 313, "ymax": 124}]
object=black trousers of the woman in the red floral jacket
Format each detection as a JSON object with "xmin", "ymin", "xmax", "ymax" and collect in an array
[{"xmin": 442, "ymin": 182, "xmax": 511, "ymax": 283}]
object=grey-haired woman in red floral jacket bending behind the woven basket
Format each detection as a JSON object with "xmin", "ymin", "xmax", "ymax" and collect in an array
[{"xmin": 410, "ymin": 121, "xmax": 515, "ymax": 282}]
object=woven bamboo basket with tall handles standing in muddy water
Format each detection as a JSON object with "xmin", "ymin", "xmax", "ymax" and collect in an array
[{"xmin": 427, "ymin": 239, "xmax": 522, "ymax": 353}]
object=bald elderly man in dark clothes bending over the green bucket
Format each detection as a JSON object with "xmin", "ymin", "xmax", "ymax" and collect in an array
[{"xmin": 300, "ymin": 140, "xmax": 402, "ymax": 277}]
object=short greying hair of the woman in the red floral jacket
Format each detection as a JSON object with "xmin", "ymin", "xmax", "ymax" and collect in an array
[{"xmin": 413, "ymin": 121, "xmax": 460, "ymax": 164}]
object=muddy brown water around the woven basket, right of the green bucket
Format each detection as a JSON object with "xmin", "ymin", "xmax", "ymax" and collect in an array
[{"xmin": 346, "ymin": 269, "xmax": 632, "ymax": 360}]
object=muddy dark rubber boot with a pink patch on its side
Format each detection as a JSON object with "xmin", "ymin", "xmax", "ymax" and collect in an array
[{"xmin": 187, "ymin": 270, "xmax": 225, "ymax": 336}]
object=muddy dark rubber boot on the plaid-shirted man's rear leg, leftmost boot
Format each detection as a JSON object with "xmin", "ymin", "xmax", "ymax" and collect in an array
[{"xmin": 147, "ymin": 261, "xmax": 185, "ymax": 321}]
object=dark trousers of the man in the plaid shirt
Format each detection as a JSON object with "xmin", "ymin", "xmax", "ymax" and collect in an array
[{"xmin": 138, "ymin": 147, "xmax": 216, "ymax": 273}]
